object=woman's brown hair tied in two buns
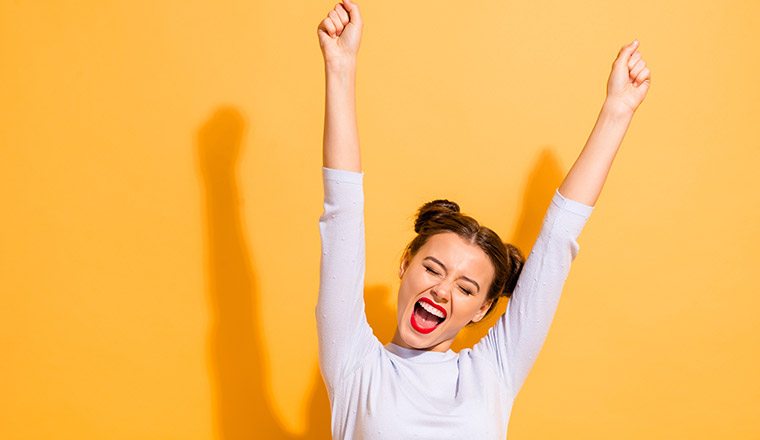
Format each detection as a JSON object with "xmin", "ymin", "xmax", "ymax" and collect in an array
[{"xmin": 404, "ymin": 200, "xmax": 525, "ymax": 317}]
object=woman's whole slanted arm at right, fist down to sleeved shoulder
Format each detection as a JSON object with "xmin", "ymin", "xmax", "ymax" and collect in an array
[{"xmin": 473, "ymin": 41, "xmax": 650, "ymax": 397}]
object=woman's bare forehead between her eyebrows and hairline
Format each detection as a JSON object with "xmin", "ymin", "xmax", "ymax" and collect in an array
[{"xmin": 415, "ymin": 232, "xmax": 494, "ymax": 280}]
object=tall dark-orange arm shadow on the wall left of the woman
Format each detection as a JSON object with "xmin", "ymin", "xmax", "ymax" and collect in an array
[{"xmin": 196, "ymin": 107, "xmax": 330, "ymax": 440}]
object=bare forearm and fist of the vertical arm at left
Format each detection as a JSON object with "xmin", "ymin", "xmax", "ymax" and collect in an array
[{"xmin": 317, "ymin": 0, "xmax": 364, "ymax": 172}]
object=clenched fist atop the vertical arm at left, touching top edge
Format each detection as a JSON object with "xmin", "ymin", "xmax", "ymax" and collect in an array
[{"xmin": 317, "ymin": 0, "xmax": 364, "ymax": 63}]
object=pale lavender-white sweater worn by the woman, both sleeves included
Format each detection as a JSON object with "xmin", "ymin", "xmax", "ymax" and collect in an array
[{"xmin": 316, "ymin": 167, "xmax": 593, "ymax": 440}]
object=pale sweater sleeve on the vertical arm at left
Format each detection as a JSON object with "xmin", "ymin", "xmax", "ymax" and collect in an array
[{"xmin": 316, "ymin": 167, "xmax": 379, "ymax": 399}]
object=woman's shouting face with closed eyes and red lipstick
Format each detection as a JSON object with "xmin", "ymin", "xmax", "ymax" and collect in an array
[{"xmin": 393, "ymin": 232, "xmax": 494, "ymax": 351}]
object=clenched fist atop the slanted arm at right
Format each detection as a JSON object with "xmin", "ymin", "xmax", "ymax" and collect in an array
[{"xmin": 607, "ymin": 40, "xmax": 652, "ymax": 112}]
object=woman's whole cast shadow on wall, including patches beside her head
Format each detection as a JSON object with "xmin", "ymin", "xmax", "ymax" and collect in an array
[{"xmin": 196, "ymin": 107, "xmax": 562, "ymax": 440}]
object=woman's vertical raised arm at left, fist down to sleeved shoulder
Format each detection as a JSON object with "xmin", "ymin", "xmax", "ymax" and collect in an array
[{"xmin": 316, "ymin": 0, "xmax": 379, "ymax": 392}]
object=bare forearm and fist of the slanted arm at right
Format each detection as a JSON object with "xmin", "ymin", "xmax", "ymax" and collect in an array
[{"xmin": 559, "ymin": 40, "xmax": 652, "ymax": 206}]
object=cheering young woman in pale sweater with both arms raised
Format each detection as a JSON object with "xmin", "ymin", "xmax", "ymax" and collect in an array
[{"xmin": 316, "ymin": 0, "xmax": 651, "ymax": 440}]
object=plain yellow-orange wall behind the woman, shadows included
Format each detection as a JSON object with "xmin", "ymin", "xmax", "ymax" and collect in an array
[{"xmin": 0, "ymin": 0, "xmax": 760, "ymax": 439}]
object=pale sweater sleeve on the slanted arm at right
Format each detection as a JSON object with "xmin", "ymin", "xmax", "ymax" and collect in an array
[{"xmin": 473, "ymin": 190, "xmax": 594, "ymax": 399}]
